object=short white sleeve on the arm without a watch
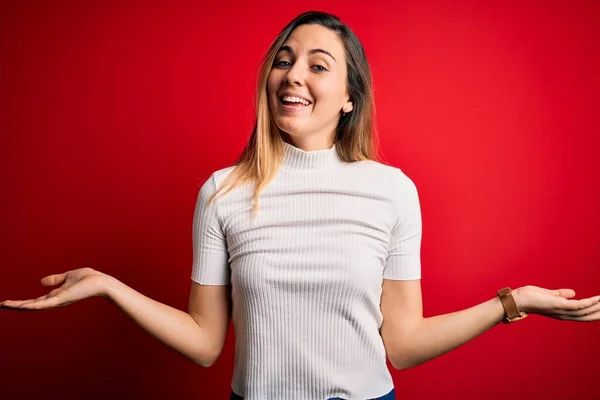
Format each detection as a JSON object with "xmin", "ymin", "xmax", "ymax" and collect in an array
[{"xmin": 192, "ymin": 174, "xmax": 230, "ymax": 285}]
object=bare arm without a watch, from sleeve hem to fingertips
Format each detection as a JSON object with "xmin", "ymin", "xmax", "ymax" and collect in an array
[{"xmin": 0, "ymin": 268, "xmax": 231, "ymax": 367}]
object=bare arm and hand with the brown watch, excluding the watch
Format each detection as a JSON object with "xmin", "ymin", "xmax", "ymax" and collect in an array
[{"xmin": 381, "ymin": 280, "xmax": 600, "ymax": 369}]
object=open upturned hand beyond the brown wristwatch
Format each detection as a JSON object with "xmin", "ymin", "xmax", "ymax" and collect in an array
[{"xmin": 513, "ymin": 285, "xmax": 600, "ymax": 322}]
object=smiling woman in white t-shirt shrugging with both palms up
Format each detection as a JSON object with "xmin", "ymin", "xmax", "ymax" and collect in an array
[{"xmin": 0, "ymin": 12, "xmax": 600, "ymax": 399}]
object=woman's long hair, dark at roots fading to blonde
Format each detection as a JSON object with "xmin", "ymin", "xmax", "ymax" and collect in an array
[{"xmin": 209, "ymin": 11, "xmax": 380, "ymax": 214}]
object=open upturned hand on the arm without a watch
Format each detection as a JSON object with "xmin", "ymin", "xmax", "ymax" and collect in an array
[{"xmin": 0, "ymin": 268, "xmax": 108, "ymax": 311}]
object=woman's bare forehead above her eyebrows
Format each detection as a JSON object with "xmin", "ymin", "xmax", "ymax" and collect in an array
[{"xmin": 284, "ymin": 24, "xmax": 344, "ymax": 60}]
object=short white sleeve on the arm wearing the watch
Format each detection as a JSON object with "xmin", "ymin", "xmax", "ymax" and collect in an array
[{"xmin": 383, "ymin": 170, "xmax": 422, "ymax": 280}]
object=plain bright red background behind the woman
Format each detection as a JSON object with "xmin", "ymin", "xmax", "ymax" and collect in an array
[{"xmin": 0, "ymin": 0, "xmax": 600, "ymax": 400}]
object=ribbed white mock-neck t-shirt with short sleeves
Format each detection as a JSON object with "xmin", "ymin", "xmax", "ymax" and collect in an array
[{"xmin": 191, "ymin": 143, "xmax": 422, "ymax": 400}]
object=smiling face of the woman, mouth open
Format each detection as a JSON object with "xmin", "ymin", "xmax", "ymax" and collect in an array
[{"xmin": 267, "ymin": 25, "xmax": 352, "ymax": 145}]
